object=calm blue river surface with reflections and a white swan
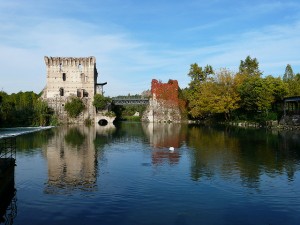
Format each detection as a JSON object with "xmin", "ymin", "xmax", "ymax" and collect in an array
[{"xmin": 0, "ymin": 123, "xmax": 300, "ymax": 225}]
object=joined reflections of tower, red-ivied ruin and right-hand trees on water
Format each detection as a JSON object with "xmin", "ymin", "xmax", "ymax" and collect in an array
[{"xmin": 19, "ymin": 123, "xmax": 300, "ymax": 193}]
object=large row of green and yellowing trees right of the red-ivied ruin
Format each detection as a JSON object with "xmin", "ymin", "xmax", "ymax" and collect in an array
[{"xmin": 181, "ymin": 56, "xmax": 300, "ymax": 122}]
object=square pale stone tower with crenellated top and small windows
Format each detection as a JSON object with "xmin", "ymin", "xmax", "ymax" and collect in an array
[{"xmin": 43, "ymin": 56, "xmax": 98, "ymax": 122}]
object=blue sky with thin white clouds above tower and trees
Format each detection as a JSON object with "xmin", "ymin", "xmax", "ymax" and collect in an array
[{"xmin": 0, "ymin": 0, "xmax": 300, "ymax": 97}]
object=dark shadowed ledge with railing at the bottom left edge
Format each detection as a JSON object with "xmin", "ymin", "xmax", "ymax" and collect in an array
[{"xmin": 0, "ymin": 137, "xmax": 17, "ymax": 225}]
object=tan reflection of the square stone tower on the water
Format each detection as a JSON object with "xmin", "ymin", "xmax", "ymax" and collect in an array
[{"xmin": 44, "ymin": 124, "xmax": 115, "ymax": 194}]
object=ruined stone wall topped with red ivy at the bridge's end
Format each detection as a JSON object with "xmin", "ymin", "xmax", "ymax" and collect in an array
[{"xmin": 142, "ymin": 79, "xmax": 181, "ymax": 122}]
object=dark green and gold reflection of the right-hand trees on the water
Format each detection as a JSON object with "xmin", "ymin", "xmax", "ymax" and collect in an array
[{"xmin": 187, "ymin": 126, "xmax": 300, "ymax": 188}]
